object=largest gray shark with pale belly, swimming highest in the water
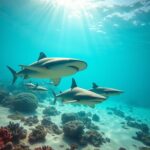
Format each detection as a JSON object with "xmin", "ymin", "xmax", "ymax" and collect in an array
[{"xmin": 7, "ymin": 52, "xmax": 87, "ymax": 85}]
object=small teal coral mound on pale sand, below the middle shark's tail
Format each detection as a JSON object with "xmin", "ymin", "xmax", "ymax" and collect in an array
[{"xmin": 43, "ymin": 106, "xmax": 60, "ymax": 116}]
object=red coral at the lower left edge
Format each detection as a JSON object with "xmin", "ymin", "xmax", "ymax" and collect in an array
[{"xmin": 0, "ymin": 127, "xmax": 12, "ymax": 150}]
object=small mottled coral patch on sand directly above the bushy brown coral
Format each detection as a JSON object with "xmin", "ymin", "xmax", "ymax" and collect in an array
[{"xmin": 23, "ymin": 116, "xmax": 39, "ymax": 126}]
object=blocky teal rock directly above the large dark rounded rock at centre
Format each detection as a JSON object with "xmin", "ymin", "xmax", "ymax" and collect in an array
[{"xmin": 61, "ymin": 113, "xmax": 78, "ymax": 124}]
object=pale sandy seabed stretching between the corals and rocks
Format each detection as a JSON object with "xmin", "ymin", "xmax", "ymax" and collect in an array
[{"xmin": 0, "ymin": 101, "xmax": 150, "ymax": 150}]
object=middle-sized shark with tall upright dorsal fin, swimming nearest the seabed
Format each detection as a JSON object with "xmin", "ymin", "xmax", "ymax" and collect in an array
[{"xmin": 53, "ymin": 79, "xmax": 106, "ymax": 108}]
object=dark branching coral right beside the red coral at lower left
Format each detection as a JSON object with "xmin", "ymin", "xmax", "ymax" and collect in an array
[{"xmin": 7, "ymin": 122, "xmax": 27, "ymax": 143}]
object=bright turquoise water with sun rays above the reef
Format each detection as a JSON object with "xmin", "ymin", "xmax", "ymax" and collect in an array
[{"xmin": 0, "ymin": 0, "xmax": 150, "ymax": 107}]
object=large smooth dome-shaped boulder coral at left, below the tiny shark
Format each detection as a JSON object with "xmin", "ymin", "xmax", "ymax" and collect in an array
[{"xmin": 12, "ymin": 93, "xmax": 38, "ymax": 113}]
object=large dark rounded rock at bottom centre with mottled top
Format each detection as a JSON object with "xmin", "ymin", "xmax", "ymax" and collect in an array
[{"xmin": 63, "ymin": 120, "xmax": 84, "ymax": 139}]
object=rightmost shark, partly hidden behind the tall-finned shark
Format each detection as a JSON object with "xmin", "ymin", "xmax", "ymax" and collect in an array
[{"xmin": 89, "ymin": 83, "xmax": 123, "ymax": 97}]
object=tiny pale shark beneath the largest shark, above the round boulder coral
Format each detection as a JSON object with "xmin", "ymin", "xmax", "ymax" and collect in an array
[{"xmin": 25, "ymin": 83, "xmax": 48, "ymax": 92}]
